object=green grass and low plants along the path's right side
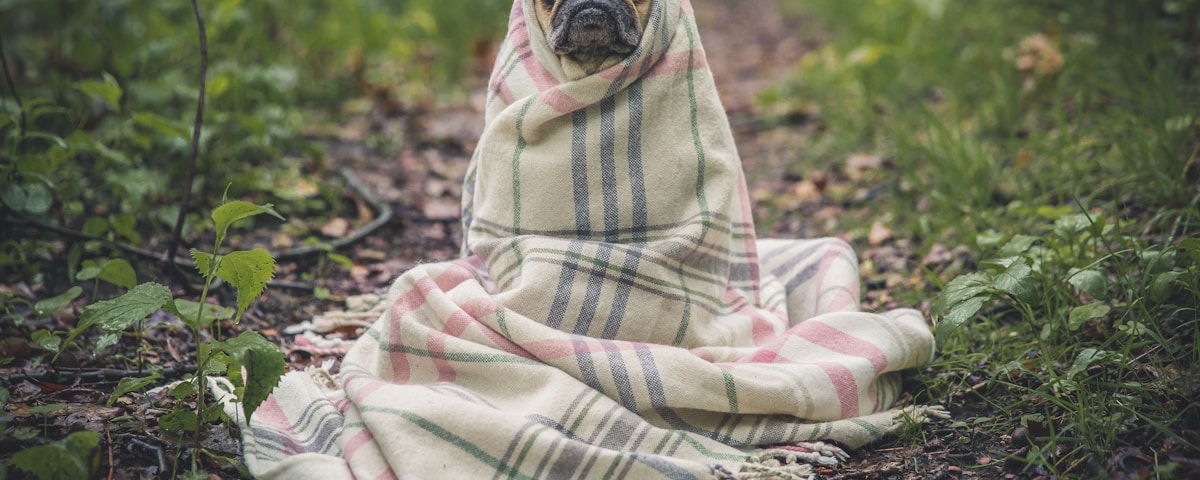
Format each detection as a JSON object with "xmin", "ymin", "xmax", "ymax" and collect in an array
[{"xmin": 760, "ymin": 0, "xmax": 1200, "ymax": 478}]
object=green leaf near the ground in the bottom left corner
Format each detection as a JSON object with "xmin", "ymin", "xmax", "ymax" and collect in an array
[{"xmin": 12, "ymin": 432, "xmax": 100, "ymax": 480}]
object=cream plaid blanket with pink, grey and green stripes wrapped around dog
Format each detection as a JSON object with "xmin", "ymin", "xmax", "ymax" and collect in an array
[{"xmin": 244, "ymin": 0, "xmax": 941, "ymax": 479}]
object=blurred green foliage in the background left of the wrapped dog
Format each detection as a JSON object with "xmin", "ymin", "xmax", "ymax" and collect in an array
[{"xmin": 0, "ymin": 0, "xmax": 511, "ymax": 277}]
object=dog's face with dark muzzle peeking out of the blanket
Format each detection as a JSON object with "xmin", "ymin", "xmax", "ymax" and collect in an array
[{"xmin": 534, "ymin": 0, "xmax": 654, "ymax": 74}]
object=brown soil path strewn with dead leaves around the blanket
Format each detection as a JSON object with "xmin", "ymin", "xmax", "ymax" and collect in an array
[{"xmin": 0, "ymin": 0, "xmax": 1171, "ymax": 479}]
